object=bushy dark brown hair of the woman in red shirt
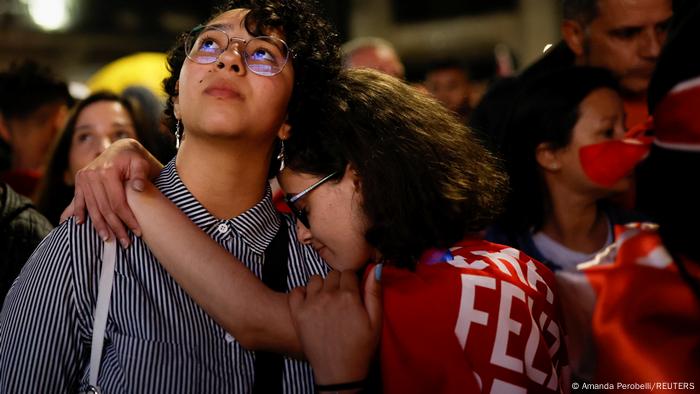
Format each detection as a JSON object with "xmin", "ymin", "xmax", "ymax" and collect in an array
[{"xmin": 285, "ymin": 69, "xmax": 507, "ymax": 268}]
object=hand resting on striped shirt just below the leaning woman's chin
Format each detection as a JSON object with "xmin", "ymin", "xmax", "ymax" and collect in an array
[{"xmin": 289, "ymin": 265, "xmax": 382, "ymax": 385}]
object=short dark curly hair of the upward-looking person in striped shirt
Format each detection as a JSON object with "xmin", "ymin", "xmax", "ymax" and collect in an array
[{"xmin": 163, "ymin": 0, "xmax": 341, "ymax": 177}]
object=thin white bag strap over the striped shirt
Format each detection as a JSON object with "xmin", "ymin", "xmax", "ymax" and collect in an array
[{"xmin": 88, "ymin": 240, "xmax": 117, "ymax": 393}]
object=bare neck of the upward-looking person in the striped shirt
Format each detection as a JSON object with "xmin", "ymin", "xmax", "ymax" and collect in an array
[{"xmin": 175, "ymin": 134, "xmax": 272, "ymax": 219}]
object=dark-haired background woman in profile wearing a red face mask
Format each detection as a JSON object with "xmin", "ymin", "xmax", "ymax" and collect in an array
[{"xmin": 486, "ymin": 67, "xmax": 648, "ymax": 271}]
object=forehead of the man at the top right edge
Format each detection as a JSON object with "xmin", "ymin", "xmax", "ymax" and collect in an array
[{"xmin": 593, "ymin": 0, "xmax": 673, "ymax": 27}]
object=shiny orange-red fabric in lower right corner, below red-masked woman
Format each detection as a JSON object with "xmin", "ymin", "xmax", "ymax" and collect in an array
[{"xmin": 565, "ymin": 223, "xmax": 700, "ymax": 389}]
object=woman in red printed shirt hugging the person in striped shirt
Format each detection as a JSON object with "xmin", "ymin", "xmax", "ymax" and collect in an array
[{"xmin": 68, "ymin": 70, "xmax": 563, "ymax": 393}]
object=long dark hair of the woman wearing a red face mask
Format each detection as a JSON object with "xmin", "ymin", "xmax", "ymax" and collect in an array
[{"xmin": 500, "ymin": 67, "xmax": 619, "ymax": 233}]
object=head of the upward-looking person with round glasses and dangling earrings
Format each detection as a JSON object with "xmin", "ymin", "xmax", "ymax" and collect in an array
[{"xmin": 164, "ymin": 0, "xmax": 340, "ymax": 176}]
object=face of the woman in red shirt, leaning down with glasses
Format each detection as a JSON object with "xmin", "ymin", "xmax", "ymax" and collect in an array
[{"xmin": 278, "ymin": 168, "xmax": 376, "ymax": 270}]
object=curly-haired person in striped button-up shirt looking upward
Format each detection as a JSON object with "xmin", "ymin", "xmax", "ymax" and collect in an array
[{"xmin": 0, "ymin": 0, "xmax": 340, "ymax": 393}]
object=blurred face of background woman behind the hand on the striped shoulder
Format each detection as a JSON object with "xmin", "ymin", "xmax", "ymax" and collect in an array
[{"xmin": 64, "ymin": 101, "xmax": 137, "ymax": 185}]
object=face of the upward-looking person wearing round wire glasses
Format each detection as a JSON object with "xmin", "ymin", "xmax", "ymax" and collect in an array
[{"xmin": 174, "ymin": 9, "xmax": 294, "ymax": 146}]
